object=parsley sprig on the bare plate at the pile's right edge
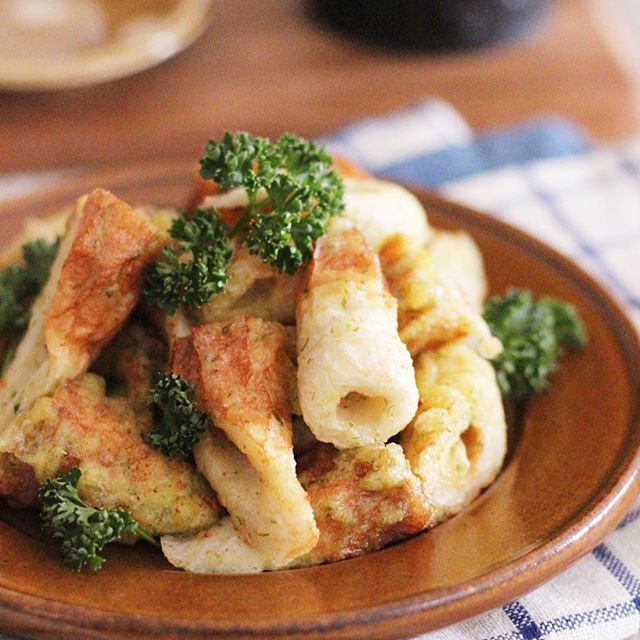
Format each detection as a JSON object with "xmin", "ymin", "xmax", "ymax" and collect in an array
[{"xmin": 483, "ymin": 289, "xmax": 587, "ymax": 401}]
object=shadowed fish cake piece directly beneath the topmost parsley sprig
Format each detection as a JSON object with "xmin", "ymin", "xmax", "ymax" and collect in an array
[{"xmin": 194, "ymin": 244, "xmax": 302, "ymax": 324}]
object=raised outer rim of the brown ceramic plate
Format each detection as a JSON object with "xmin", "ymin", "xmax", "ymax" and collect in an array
[{"xmin": 0, "ymin": 160, "xmax": 640, "ymax": 638}]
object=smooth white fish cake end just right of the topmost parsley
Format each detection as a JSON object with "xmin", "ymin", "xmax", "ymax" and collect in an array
[{"xmin": 342, "ymin": 178, "xmax": 433, "ymax": 251}]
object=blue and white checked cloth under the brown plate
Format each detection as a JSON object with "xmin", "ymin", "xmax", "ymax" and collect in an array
[{"xmin": 0, "ymin": 100, "xmax": 640, "ymax": 640}]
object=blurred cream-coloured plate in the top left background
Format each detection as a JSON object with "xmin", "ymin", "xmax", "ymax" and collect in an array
[{"xmin": 0, "ymin": 0, "xmax": 213, "ymax": 91}]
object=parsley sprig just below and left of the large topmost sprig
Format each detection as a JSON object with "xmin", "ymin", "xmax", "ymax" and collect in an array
[{"xmin": 143, "ymin": 209, "xmax": 232, "ymax": 315}]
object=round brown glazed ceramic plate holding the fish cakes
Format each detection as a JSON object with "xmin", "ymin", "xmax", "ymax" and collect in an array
[{"xmin": 0, "ymin": 163, "xmax": 640, "ymax": 640}]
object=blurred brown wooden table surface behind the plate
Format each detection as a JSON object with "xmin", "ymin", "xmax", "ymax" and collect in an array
[{"xmin": 0, "ymin": 0, "xmax": 640, "ymax": 171}]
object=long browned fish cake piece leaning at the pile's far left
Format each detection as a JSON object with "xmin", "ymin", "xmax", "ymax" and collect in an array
[{"xmin": 0, "ymin": 189, "xmax": 162, "ymax": 431}]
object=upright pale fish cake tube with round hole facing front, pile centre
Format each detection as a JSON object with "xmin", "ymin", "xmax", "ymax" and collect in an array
[{"xmin": 297, "ymin": 229, "xmax": 418, "ymax": 449}]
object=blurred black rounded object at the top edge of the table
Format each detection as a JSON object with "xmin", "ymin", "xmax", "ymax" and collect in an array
[{"xmin": 311, "ymin": 0, "xmax": 551, "ymax": 51}]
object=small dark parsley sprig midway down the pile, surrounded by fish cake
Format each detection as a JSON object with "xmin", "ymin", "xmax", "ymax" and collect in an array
[{"xmin": 148, "ymin": 373, "xmax": 210, "ymax": 458}]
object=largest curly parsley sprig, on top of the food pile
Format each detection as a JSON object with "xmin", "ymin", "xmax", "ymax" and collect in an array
[{"xmin": 200, "ymin": 132, "xmax": 344, "ymax": 274}]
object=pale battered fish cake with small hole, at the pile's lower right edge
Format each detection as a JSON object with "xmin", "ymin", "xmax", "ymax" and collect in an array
[{"xmin": 401, "ymin": 342, "xmax": 507, "ymax": 525}]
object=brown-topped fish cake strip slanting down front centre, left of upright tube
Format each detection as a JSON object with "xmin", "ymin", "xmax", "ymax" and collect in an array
[{"xmin": 171, "ymin": 316, "xmax": 318, "ymax": 573}]
